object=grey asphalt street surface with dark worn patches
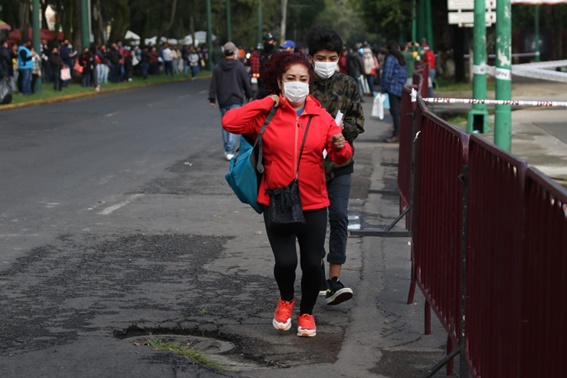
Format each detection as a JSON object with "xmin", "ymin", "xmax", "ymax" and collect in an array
[{"xmin": 0, "ymin": 75, "xmax": 565, "ymax": 377}]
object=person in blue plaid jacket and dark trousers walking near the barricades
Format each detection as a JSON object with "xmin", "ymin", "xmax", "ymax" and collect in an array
[{"xmin": 380, "ymin": 41, "xmax": 407, "ymax": 143}]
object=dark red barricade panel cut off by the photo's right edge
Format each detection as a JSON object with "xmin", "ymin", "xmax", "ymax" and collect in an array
[{"xmin": 518, "ymin": 167, "xmax": 567, "ymax": 377}]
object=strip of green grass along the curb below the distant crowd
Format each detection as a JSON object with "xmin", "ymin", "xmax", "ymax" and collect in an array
[{"xmin": 11, "ymin": 71, "xmax": 211, "ymax": 105}]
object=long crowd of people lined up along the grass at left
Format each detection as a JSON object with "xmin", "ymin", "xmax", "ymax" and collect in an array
[{"xmin": 0, "ymin": 39, "xmax": 208, "ymax": 96}]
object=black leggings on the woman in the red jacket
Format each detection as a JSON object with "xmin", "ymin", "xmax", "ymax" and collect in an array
[{"xmin": 264, "ymin": 208, "xmax": 327, "ymax": 314}]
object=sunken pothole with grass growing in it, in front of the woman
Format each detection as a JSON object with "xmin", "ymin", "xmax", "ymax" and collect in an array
[{"xmin": 114, "ymin": 326, "xmax": 264, "ymax": 372}]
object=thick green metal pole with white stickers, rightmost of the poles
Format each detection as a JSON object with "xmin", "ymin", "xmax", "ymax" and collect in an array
[{"xmin": 494, "ymin": 0, "xmax": 512, "ymax": 151}]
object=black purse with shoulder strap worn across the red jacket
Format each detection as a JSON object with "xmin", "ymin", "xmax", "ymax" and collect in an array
[{"xmin": 265, "ymin": 116, "xmax": 312, "ymax": 233}]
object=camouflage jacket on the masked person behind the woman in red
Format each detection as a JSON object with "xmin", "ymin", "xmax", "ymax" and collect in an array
[{"xmin": 310, "ymin": 72, "xmax": 364, "ymax": 180}]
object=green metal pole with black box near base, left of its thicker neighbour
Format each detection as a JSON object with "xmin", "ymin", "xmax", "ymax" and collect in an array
[{"xmin": 467, "ymin": 0, "xmax": 490, "ymax": 133}]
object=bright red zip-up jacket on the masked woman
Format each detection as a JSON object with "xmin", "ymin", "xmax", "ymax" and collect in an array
[{"xmin": 222, "ymin": 95, "xmax": 352, "ymax": 210}]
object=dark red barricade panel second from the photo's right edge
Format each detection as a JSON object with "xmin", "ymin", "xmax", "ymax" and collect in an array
[{"xmin": 465, "ymin": 135, "xmax": 527, "ymax": 378}]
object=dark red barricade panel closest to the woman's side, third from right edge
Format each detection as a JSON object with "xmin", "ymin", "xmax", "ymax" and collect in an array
[{"xmin": 412, "ymin": 99, "xmax": 468, "ymax": 340}]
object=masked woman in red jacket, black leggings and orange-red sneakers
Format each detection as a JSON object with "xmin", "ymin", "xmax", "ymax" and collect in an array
[{"xmin": 222, "ymin": 53, "xmax": 352, "ymax": 337}]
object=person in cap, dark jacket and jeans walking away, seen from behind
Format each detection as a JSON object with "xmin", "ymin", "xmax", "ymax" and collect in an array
[{"xmin": 209, "ymin": 42, "xmax": 252, "ymax": 160}]
